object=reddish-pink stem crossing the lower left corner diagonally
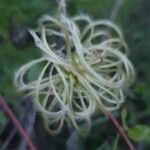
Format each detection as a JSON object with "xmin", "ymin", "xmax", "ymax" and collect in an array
[{"xmin": 0, "ymin": 95, "xmax": 36, "ymax": 150}]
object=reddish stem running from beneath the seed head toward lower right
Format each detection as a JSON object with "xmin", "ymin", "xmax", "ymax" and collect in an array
[{"xmin": 106, "ymin": 112, "xmax": 135, "ymax": 150}]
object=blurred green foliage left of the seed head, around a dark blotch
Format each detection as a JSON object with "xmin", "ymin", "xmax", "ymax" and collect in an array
[{"xmin": 0, "ymin": 0, "xmax": 55, "ymax": 105}]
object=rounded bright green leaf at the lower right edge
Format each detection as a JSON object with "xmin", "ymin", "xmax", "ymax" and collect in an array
[{"xmin": 127, "ymin": 125, "xmax": 150, "ymax": 142}]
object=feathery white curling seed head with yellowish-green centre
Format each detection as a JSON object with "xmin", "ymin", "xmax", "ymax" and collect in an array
[{"xmin": 15, "ymin": 15, "xmax": 135, "ymax": 134}]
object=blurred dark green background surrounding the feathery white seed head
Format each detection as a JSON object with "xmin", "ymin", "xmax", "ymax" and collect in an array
[{"xmin": 0, "ymin": 0, "xmax": 150, "ymax": 150}]
